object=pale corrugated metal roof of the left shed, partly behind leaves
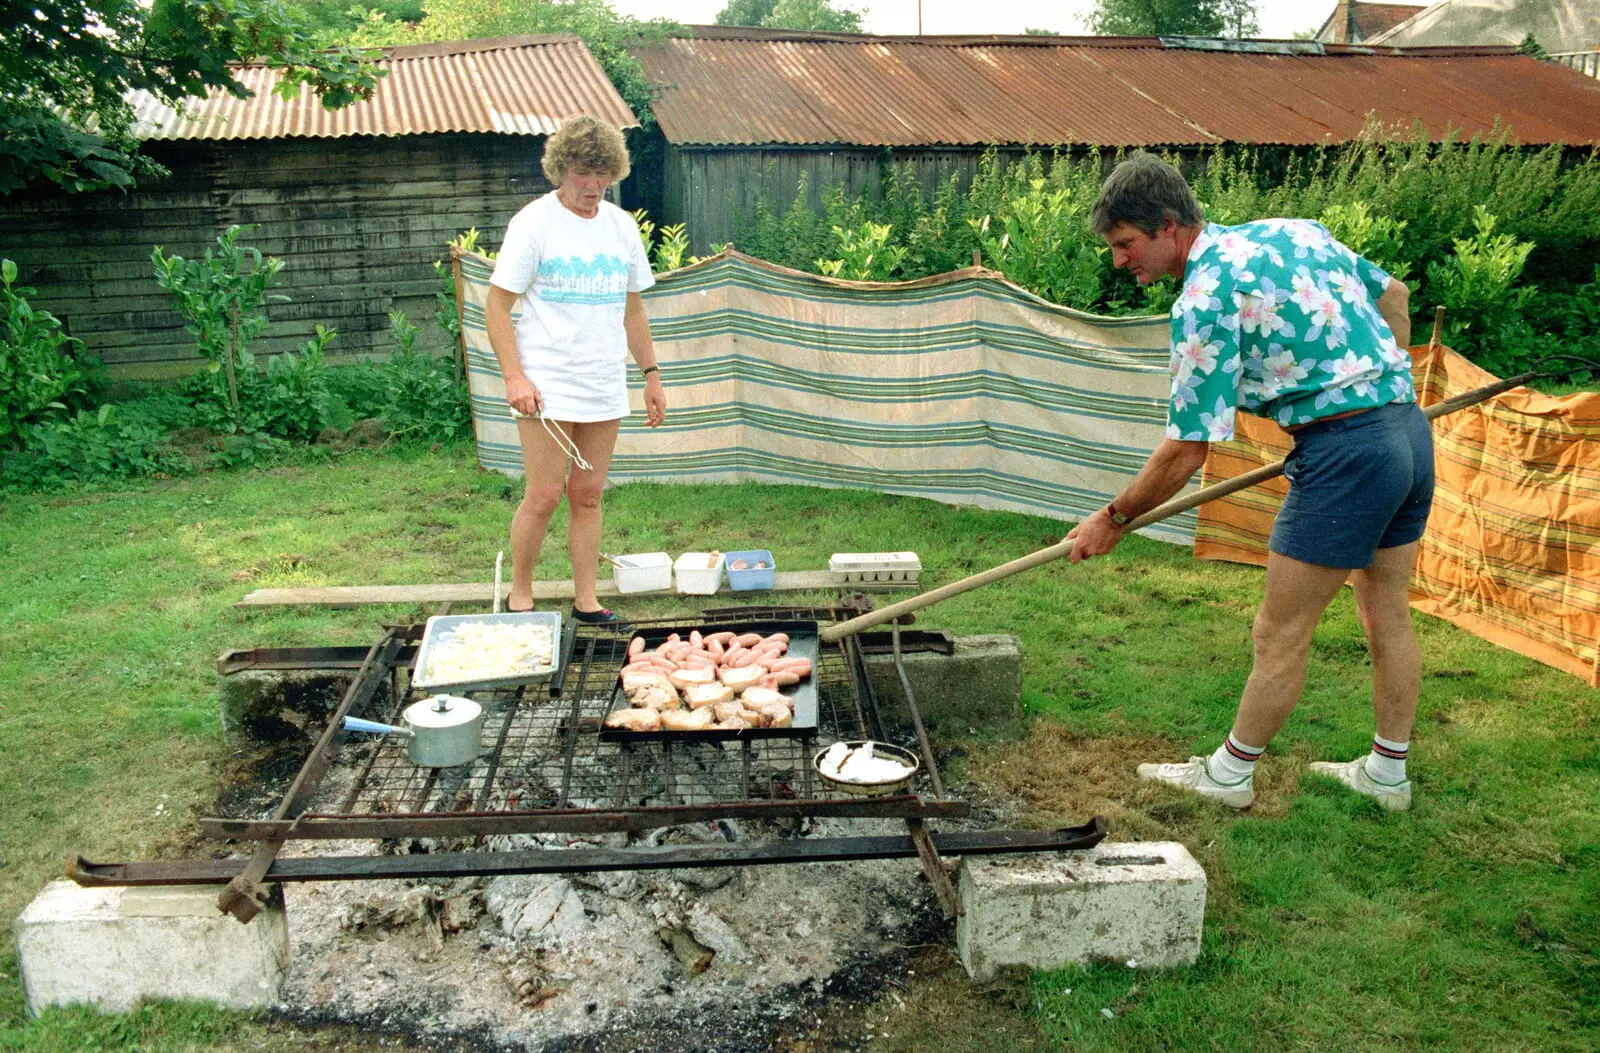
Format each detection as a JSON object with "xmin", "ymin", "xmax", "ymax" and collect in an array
[{"xmin": 130, "ymin": 34, "xmax": 638, "ymax": 139}]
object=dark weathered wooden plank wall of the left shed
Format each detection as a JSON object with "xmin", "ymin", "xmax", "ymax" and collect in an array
[{"xmin": 0, "ymin": 134, "xmax": 549, "ymax": 379}]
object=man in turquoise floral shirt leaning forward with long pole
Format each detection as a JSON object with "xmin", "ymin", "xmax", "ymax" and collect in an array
[{"xmin": 1067, "ymin": 152, "xmax": 1434, "ymax": 810}]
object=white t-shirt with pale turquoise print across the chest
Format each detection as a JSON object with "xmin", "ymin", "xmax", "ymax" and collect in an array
[{"xmin": 490, "ymin": 190, "xmax": 656, "ymax": 421}]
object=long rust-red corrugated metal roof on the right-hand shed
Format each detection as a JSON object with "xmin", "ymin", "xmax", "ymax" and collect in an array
[{"xmin": 634, "ymin": 26, "xmax": 1600, "ymax": 146}]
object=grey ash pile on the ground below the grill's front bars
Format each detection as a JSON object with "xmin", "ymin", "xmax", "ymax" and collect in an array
[{"xmin": 285, "ymin": 819, "xmax": 946, "ymax": 1053}]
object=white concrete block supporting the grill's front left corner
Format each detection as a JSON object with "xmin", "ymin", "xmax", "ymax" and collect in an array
[{"xmin": 13, "ymin": 880, "xmax": 290, "ymax": 1015}]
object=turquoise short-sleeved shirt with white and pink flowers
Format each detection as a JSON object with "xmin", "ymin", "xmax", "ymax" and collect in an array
[{"xmin": 1166, "ymin": 219, "xmax": 1416, "ymax": 442}]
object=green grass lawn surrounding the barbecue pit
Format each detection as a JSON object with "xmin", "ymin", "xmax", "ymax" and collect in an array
[{"xmin": 0, "ymin": 450, "xmax": 1600, "ymax": 1053}]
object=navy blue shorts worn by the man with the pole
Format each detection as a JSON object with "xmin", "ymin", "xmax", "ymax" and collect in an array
[{"xmin": 1270, "ymin": 402, "xmax": 1434, "ymax": 570}]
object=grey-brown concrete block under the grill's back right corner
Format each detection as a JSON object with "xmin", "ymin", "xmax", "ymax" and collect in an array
[{"xmin": 867, "ymin": 632, "xmax": 1022, "ymax": 733}]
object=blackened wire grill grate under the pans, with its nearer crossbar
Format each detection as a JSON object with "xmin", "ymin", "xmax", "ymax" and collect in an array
[{"xmin": 200, "ymin": 607, "xmax": 968, "ymax": 840}]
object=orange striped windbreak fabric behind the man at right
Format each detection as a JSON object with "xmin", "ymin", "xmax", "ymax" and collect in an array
[{"xmin": 1195, "ymin": 346, "xmax": 1600, "ymax": 687}]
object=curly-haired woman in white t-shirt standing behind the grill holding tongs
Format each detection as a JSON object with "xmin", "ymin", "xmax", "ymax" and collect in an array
[{"xmin": 485, "ymin": 117, "xmax": 667, "ymax": 623}]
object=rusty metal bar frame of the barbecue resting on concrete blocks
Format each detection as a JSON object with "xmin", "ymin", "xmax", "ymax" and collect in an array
[{"xmin": 67, "ymin": 608, "xmax": 1106, "ymax": 923}]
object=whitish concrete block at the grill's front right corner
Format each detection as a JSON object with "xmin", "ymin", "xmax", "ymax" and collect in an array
[{"xmin": 955, "ymin": 842, "xmax": 1205, "ymax": 979}]
